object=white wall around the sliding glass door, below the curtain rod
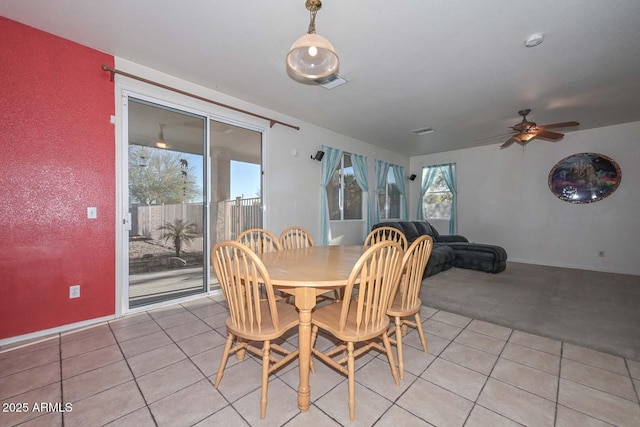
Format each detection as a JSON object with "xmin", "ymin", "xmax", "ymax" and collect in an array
[{"xmin": 113, "ymin": 58, "xmax": 409, "ymax": 249}]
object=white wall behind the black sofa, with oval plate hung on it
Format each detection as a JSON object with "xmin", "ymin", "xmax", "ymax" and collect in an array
[{"xmin": 409, "ymin": 122, "xmax": 640, "ymax": 275}]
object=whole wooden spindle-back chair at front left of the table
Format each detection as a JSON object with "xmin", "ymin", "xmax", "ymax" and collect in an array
[{"xmin": 211, "ymin": 240, "xmax": 299, "ymax": 418}]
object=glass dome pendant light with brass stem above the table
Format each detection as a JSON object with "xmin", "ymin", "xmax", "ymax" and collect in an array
[{"xmin": 287, "ymin": 0, "xmax": 340, "ymax": 80}]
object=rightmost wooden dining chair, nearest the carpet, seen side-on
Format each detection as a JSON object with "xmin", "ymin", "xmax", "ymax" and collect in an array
[{"xmin": 387, "ymin": 235, "xmax": 433, "ymax": 379}]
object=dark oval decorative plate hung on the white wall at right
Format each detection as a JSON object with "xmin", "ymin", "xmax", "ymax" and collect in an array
[{"xmin": 549, "ymin": 153, "xmax": 621, "ymax": 203}]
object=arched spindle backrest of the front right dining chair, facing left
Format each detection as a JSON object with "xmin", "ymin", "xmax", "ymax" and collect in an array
[{"xmin": 339, "ymin": 240, "xmax": 403, "ymax": 333}]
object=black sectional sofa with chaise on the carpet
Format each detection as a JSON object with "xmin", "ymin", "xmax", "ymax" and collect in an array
[{"xmin": 372, "ymin": 221, "xmax": 507, "ymax": 277}]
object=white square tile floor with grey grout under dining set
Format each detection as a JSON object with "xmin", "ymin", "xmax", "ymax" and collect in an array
[{"xmin": 0, "ymin": 298, "xmax": 640, "ymax": 427}]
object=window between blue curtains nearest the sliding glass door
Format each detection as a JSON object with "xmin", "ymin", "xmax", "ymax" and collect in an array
[{"xmin": 327, "ymin": 153, "xmax": 363, "ymax": 221}]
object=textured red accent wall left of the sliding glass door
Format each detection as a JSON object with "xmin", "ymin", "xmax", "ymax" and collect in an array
[{"xmin": 0, "ymin": 17, "xmax": 115, "ymax": 339}]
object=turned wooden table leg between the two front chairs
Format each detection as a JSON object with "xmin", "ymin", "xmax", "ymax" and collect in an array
[{"xmin": 296, "ymin": 288, "xmax": 316, "ymax": 412}]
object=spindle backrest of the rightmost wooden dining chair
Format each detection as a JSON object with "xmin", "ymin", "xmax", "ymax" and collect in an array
[{"xmin": 394, "ymin": 235, "xmax": 433, "ymax": 310}]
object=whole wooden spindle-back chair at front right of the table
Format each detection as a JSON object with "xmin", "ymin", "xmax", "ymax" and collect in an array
[{"xmin": 311, "ymin": 240, "xmax": 403, "ymax": 421}]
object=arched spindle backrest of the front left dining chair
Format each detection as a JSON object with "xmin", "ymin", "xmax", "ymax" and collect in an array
[{"xmin": 211, "ymin": 240, "xmax": 278, "ymax": 334}]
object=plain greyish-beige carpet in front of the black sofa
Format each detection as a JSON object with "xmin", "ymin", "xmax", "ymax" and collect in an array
[{"xmin": 420, "ymin": 262, "xmax": 640, "ymax": 361}]
